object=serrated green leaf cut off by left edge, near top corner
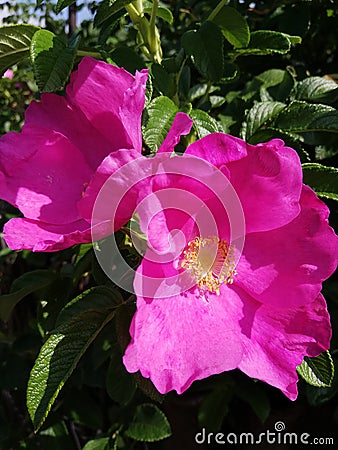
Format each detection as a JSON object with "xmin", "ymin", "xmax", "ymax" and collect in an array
[{"xmin": 0, "ymin": 25, "xmax": 40, "ymax": 73}]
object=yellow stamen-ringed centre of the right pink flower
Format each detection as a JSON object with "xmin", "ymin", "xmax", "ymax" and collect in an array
[{"xmin": 181, "ymin": 236, "xmax": 237, "ymax": 295}]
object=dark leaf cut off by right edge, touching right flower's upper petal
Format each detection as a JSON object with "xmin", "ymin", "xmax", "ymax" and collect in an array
[{"xmin": 302, "ymin": 163, "xmax": 338, "ymax": 200}]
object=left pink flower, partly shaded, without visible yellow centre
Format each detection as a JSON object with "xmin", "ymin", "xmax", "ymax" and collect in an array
[{"xmin": 0, "ymin": 57, "xmax": 147, "ymax": 251}]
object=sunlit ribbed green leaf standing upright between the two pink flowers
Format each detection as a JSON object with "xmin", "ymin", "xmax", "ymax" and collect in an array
[{"xmin": 143, "ymin": 97, "xmax": 178, "ymax": 153}]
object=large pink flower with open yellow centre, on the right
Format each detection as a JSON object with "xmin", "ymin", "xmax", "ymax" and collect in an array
[{"xmin": 88, "ymin": 131, "xmax": 338, "ymax": 400}]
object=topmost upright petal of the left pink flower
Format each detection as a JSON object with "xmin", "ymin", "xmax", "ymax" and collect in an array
[{"xmin": 67, "ymin": 57, "xmax": 148, "ymax": 152}]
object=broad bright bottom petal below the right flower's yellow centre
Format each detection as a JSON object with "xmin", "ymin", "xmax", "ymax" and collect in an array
[{"xmin": 123, "ymin": 257, "xmax": 242, "ymax": 393}]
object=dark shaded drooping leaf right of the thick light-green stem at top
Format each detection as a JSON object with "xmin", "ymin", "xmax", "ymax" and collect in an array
[{"xmin": 182, "ymin": 22, "xmax": 224, "ymax": 81}]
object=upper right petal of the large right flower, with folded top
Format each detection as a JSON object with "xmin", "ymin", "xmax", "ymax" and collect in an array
[{"xmin": 189, "ymin": 133, "xmax": 302, "ymax": 233}]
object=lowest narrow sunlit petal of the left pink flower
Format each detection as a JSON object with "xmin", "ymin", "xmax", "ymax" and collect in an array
[{"xmin": 4, "ymin": 218, "xmax": 91, "ymax": 252}]
